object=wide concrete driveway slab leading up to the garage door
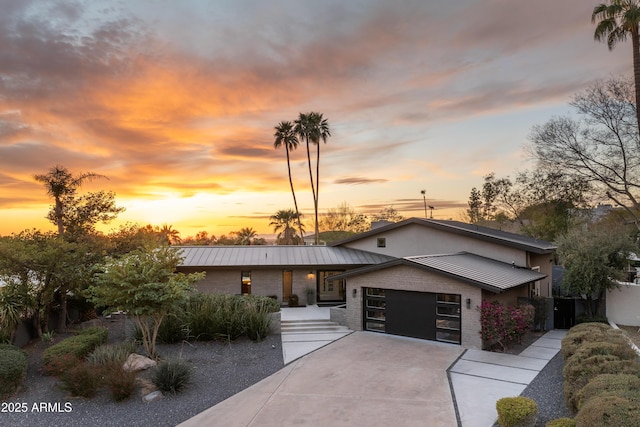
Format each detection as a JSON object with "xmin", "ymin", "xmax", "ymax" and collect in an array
[{"xmin": 180, "ymin": 332, "xmax": 463, "ymax": 427}]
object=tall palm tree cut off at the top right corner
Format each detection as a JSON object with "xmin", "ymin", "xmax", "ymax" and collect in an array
[{"xmin": 591, "ymin": 0, "xmax": 640, "ymax": 128}]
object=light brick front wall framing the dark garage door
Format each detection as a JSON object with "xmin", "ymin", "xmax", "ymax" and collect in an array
[{"xmin": 347, "ymin": 266, "xmax": 482, "ymax": 348}]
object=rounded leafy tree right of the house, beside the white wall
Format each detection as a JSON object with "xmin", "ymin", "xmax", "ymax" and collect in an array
[{"xmin": 557, "ymin": 226, "xmax": 637, "ymax": 317}]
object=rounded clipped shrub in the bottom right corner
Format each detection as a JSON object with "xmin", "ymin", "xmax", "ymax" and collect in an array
[{"xmin": 576, "ymin": 396, "xmax": 640, "ymax": 427}]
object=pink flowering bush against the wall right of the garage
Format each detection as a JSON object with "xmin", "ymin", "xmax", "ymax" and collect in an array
[{"xmin": 478, "ymin": 301, "xmax": 535, "ymax": 351}]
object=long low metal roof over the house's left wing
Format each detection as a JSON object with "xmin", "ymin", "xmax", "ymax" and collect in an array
[{"xmin": 179, "ymin": 246, "xmax": 394, "ymax": 267}]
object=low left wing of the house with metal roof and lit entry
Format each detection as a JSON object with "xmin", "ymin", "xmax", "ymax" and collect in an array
[{"xmin": 178, "ymin": 246, "xmax": 393, "ymax": 304}]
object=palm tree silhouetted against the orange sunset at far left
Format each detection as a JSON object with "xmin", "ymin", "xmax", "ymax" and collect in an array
[{"xmin": 33, "ymin": 165, "xmax": 108, "ymax": 236}]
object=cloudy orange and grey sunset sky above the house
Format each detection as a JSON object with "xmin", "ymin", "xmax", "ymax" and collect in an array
[{"xmin": 0, "ymin": 0, "xmax": 632, "ymax": 237}]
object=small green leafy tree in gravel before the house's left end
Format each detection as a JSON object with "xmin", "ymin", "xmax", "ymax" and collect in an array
[{"xmin": 88, "ymin": 246, "xmax": 204, "ymax": 357}]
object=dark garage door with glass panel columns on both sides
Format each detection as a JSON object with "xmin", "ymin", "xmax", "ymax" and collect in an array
[{"xmin": 363, "ymin": 288, "xmax": 461, "ymax": 344}]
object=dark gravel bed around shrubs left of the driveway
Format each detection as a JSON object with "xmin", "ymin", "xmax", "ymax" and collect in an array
[{"xmin": 0, "ymin": 318, "xmax": 283, "ymax": 427}]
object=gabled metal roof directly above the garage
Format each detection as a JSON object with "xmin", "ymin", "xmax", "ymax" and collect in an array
[{"xmin": 335, "ymin": 252, "xmax": 547, "ymax": 293}]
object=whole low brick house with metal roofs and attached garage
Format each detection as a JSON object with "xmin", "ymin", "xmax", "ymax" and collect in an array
[{"xmin": 180, "ymin": 218, "xmax": 556, "ymax": 348}]
